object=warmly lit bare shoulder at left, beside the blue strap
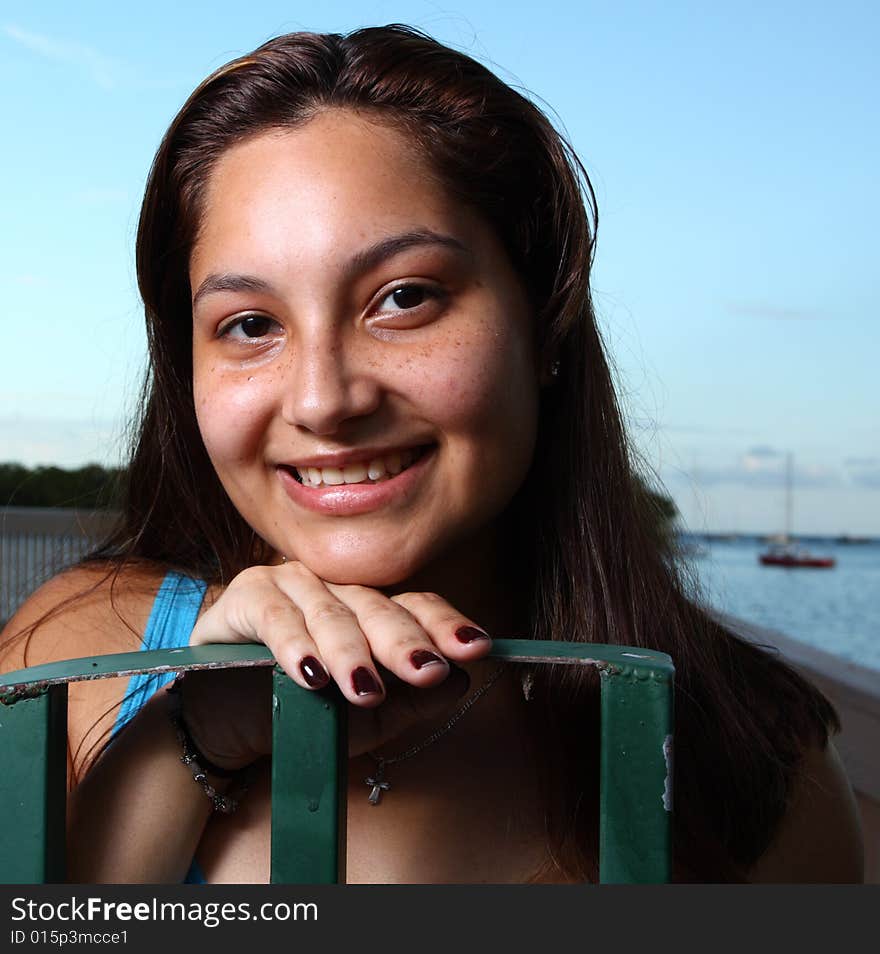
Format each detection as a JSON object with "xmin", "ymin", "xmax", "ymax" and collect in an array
[{"xmin": 0, "ymin": 565, "xmax": 170, "ymax": 778}]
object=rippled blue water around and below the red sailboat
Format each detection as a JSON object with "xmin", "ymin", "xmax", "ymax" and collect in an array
[{"xmin": 688, "ymin": 537, "xmax": 880, "ymax": 678}]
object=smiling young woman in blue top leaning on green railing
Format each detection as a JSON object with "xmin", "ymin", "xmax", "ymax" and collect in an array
[{"xmin": 4, "ymin": 27, "xmax": 861, "ymax": 883}]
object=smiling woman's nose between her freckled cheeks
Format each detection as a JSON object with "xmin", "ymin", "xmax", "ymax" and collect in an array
[{"xmin": 282, "ymin": 335, "xmax": 382, "ymax": 435}]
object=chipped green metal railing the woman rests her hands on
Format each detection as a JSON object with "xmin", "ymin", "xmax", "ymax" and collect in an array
[{"xmin": 0, "ymin": 639, "xmax": 675, "ymax": 884}]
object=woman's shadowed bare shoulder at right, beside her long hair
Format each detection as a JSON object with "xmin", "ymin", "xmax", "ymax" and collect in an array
[{"xmin": 749, "ymin": 741, "xmax": 864, "ymax": 884}]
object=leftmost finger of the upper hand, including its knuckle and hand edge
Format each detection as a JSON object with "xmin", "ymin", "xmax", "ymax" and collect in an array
[{"xmin": 190, "ymin": 567, "xmax": 330, "ymax": 689}]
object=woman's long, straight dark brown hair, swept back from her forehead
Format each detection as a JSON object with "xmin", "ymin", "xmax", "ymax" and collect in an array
[{"xmin": 91, "ymin": 25, "xmax": 836, "ymax": 880}]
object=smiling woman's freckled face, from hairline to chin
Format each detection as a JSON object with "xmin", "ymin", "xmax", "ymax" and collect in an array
[{"xmin": 190, "ymin": 110, "xmax": 538, "ymax": 586}]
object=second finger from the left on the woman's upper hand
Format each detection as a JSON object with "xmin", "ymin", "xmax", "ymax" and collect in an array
[{"xmin": 274, "ymin": 563, "xmax": 385, "ymax": 706}]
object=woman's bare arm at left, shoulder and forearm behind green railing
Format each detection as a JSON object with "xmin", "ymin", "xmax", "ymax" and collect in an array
[{"xmin": 0, "ymin": 567, "xmax": 222, "ymax": 883}]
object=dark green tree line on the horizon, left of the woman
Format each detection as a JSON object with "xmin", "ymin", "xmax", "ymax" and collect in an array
[{"xmin": 0, "ymin": 463, "xmax": 124, "ymax": 510}]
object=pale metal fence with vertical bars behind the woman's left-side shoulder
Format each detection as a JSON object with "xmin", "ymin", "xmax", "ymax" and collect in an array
[{"xmin": 0, "ymin": 507, "xmax": 116, "ymax": 625}]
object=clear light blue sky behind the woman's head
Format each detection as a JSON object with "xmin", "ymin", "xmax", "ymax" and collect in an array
[{"xmin": 0, "ymin": 0, "xmax": 880, "ymax": 534}]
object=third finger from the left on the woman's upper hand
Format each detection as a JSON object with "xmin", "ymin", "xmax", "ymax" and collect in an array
[{"xmin": 326, "ymin": 583, "xmax": 449, "ymax": 688}]
